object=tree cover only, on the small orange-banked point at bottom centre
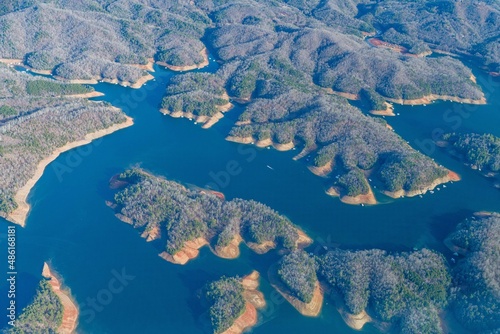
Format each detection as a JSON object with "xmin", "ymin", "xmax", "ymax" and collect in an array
[{"xmin": 204, "ymin": 277, "xmax": 246, "ymax": 334}]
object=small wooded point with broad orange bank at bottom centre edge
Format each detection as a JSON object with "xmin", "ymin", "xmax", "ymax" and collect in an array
[{"xmin": 203, "ymin": 271, "xmax": 266, "ymax": 334}]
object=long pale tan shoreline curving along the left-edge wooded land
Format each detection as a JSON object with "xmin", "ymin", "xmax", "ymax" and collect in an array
[{"xmin": 6, "ymin": 116, "xmax": 134, "ymax": 227}]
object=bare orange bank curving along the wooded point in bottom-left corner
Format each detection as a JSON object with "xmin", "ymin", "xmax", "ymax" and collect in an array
[{"xmin": 42, "ymin": 262, "xmax": 79, "ymax": 334}]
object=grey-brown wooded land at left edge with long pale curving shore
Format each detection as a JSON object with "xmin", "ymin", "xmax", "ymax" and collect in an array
[{"xmin": 0, "ymin": 64, "xmax": 133, "ymax": 225}]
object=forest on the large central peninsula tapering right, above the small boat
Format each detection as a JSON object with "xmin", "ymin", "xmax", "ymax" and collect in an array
[{"xmin": 230, "ymin": 93, "xmax": 447, "ymax": 196}]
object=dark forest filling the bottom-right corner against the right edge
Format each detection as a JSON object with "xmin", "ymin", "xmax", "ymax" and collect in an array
[{"xmin": 448, "ymin": 214, "xmax": 500, "ymax": 333}]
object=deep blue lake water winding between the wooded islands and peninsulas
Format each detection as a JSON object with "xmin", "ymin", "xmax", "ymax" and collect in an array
[{"xmin": 0, "ymin": 59, "xmax": 500, "ymax": 333}]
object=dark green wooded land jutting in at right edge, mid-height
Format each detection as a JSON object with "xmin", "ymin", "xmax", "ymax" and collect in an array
[{"xmin": 437, "ymin": 133, "xmax": 500, "ymax": 189}]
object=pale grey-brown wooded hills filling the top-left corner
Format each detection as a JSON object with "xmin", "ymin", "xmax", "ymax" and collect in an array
[{"xmin": 0, "ymin": 0, "xmax": 209, "ymax": 83}]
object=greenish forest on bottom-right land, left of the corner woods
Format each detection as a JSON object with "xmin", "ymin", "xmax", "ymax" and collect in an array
[{"xmin": 319, "ymin": 249, "xmax": 451, "ymax": 333}]
